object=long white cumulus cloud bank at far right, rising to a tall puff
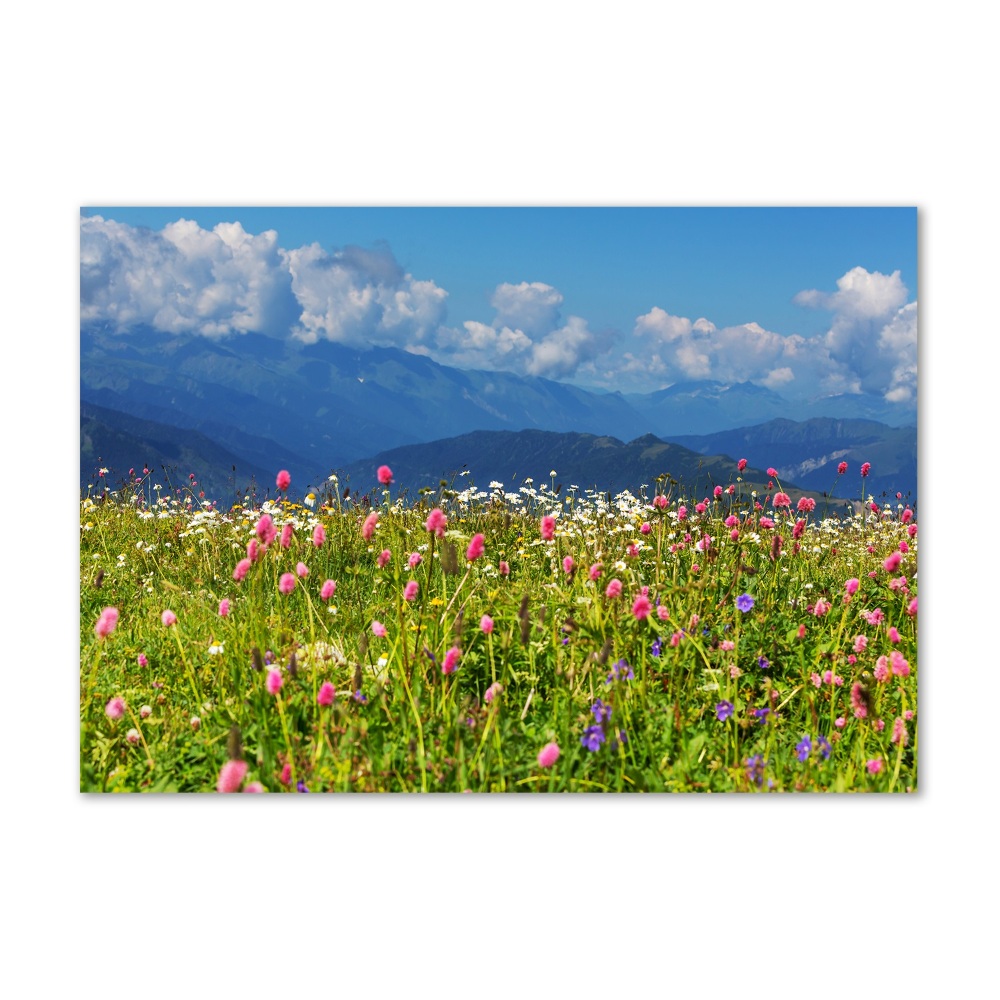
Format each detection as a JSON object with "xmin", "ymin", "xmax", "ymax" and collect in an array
[{"xmin": 624, "ymin": 267, "xmax": 917, "ymax": 404}]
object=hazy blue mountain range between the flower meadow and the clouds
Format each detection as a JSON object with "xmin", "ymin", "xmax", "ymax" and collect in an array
[{"xmin": 80, "ymin": 327, "xmax": 916, "ymax": 499}]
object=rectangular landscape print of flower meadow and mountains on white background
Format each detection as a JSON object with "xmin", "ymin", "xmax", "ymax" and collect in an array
[{"xmin": 80, "ymin": 206, "xmax": 918, "ymax": 794}]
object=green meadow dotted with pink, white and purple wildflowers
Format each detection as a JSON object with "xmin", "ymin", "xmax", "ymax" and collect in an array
[{"xmin": 80, "ymin": 462, "xmax": 917, "ymax": 793}]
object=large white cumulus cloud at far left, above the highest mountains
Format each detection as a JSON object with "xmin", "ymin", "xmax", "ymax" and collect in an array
[{"xmin": 80, "ymin": 216, "xmax": 299, "ymax": 337}]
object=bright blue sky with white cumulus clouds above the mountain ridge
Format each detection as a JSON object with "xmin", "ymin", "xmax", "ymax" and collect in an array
[{"xmin": 82, "ymin": 206, "xmax": 917, "ymax": 406}]
